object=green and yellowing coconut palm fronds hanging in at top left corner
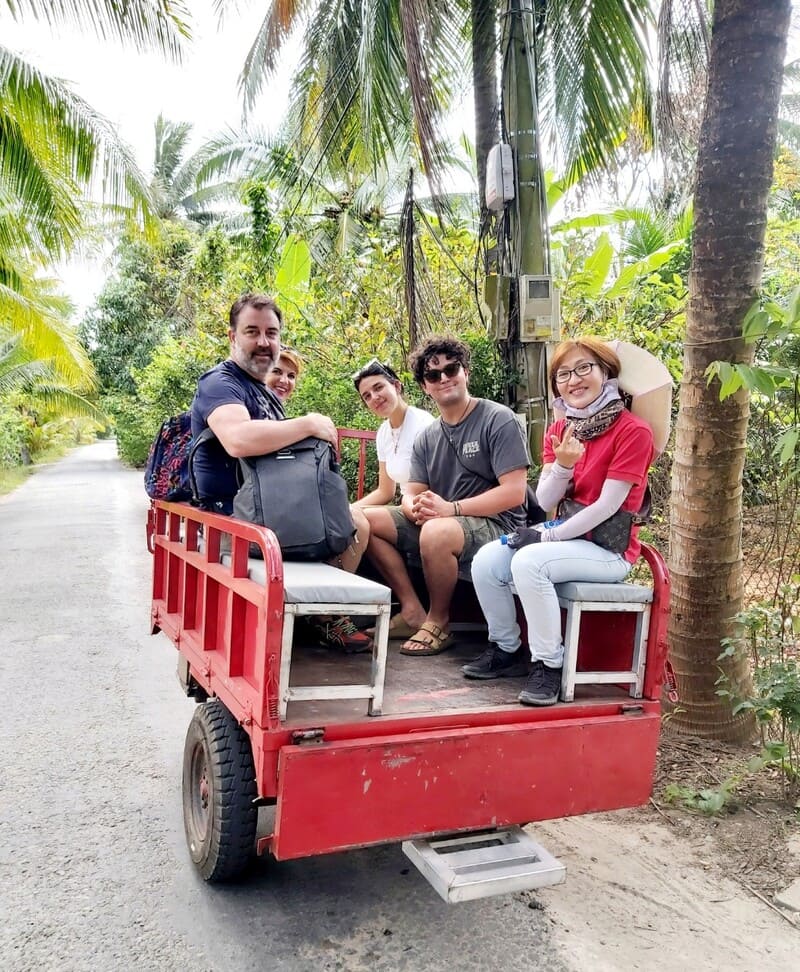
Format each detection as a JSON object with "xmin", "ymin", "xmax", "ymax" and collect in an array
[{"xmin": 0, "ymin": 0, "xmax": 188, "ymax": 374}]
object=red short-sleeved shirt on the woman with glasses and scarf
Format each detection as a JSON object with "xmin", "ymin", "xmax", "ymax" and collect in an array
[{"xmin": 542, "ymin": 409, "xmax": 655, "ymax": 564}]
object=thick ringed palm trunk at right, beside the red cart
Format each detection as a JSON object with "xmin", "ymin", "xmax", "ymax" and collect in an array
[{"xmin": 670, "ymin": 0, "xmax": 791, "ymax": 742}]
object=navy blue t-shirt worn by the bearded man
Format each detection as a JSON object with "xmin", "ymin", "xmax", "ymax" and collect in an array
[{"xmin": 191, "ymin": 359, "xmax": 286, "ymax": 513}]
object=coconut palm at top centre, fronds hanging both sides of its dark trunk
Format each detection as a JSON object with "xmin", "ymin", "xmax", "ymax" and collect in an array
[{"xmin": 227, "ymin": 0, "xmax": 652, "ymax": 194}]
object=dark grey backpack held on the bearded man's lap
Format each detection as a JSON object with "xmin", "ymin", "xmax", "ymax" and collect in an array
[{"xmin": 233, "ymin": 437, "xmax": 356, "ymax": 561}]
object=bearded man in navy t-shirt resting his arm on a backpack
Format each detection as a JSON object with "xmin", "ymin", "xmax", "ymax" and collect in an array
[{"xmin": 192, "ymin": 294, "xmax": 372, "ymax": 652}]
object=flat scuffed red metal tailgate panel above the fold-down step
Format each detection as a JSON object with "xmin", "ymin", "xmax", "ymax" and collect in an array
[{"xmin": 270, "ymin": 704, "xmax": 660, "ymax": 859}]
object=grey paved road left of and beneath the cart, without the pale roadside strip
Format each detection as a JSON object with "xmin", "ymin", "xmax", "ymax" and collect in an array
[{"xmin": 0, "ymin": 442, "xmax": 570, "ymax": 972}]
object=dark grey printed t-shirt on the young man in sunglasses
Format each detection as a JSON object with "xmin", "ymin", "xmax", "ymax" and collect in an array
[{"xmin": 409, "ymin": 398, "xmax": 531, "ymax": 532}]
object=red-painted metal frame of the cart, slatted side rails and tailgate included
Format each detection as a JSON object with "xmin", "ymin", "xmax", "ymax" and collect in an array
[{"xmin": 148, "ymin": 430, "xmax": 669, "ymax": 858}]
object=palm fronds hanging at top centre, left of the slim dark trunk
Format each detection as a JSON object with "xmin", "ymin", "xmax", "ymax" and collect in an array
[{"xmin": 234, "ymin": 0, "xmax": 466, "ymax": 197}]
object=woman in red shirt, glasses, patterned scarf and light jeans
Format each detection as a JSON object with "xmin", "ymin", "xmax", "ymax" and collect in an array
[{"xmin": 462, "ymin": 337, "xmax": 655, "ymax": 705}]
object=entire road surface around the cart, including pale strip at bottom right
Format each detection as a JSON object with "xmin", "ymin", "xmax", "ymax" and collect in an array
[{"xmin": 0, "ymin": 442, "xmax": 800, "ymax": 972}]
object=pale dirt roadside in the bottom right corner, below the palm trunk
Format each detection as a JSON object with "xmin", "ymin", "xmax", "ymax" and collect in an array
[{"xmin": 527, "ymin": 740, "xmax": 800, "ymax": 972}]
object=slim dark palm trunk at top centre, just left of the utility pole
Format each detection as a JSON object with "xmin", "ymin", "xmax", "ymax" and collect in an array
[{"xmin": 471, "ymin": 0, "xmax": 499, "ymax": 210}]
